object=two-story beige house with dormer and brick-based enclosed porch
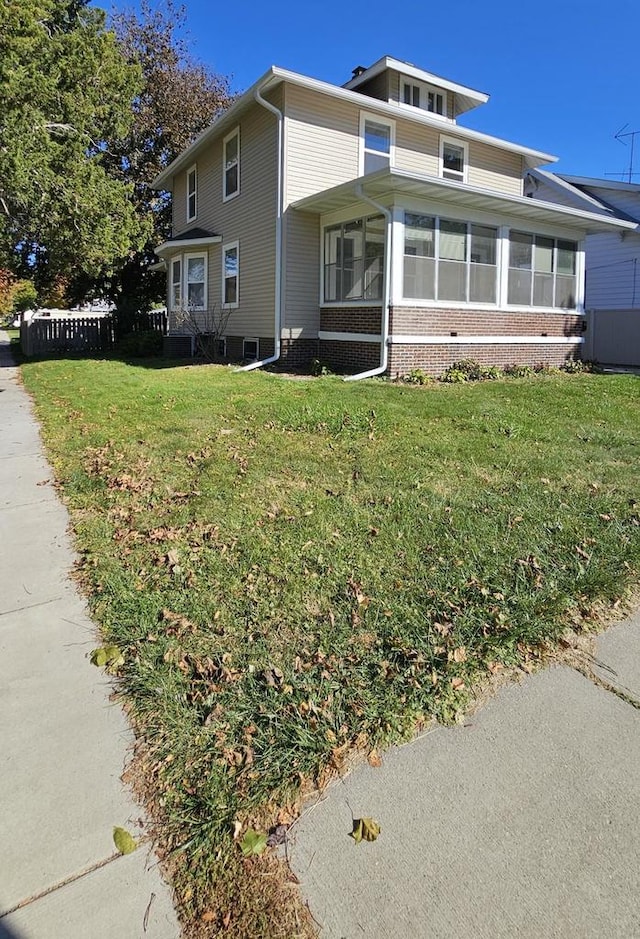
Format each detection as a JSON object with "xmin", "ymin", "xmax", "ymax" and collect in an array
[{"xmin": 153, "ymin": 57, "xmax": 633, "ymax": 376}]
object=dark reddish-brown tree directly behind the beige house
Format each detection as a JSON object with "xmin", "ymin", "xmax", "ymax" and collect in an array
[{"xmin": 99, "ymin": 0, "xmax": 233, "ymax": 308}]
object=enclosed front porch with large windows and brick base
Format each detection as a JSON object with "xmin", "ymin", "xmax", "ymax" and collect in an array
[{"xmin": 294, "ymin": 169, "xmax": 636, "ymax": 374}]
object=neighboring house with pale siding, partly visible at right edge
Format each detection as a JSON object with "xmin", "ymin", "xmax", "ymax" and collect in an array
[{"xmin": 525, "ymin": 170, "xmax": 640, "ymax": 366}]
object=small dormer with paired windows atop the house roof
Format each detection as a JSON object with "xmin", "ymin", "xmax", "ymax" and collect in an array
[{"xmin": 343, "ymin": 55, "xmax": 489, "ymax": 123}]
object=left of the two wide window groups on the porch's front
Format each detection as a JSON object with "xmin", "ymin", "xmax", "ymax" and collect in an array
[{"xmin": 403, "ymin": 212, "xmax": 498, "ymax": 303}]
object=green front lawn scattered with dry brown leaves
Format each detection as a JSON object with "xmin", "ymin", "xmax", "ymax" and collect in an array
[{"xmin": 23, "ymin": 361, "xmax": 640, "ymax": 936}]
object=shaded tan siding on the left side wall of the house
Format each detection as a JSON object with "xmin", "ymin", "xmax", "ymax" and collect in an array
[{"xmin": 173, "ymin": 94, "xmax": 281, "ymax": 337}]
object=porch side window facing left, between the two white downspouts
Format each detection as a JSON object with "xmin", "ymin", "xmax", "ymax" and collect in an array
[{"xmin": 324, "ymin": 215, "xmax": 385, "ymax": 303}]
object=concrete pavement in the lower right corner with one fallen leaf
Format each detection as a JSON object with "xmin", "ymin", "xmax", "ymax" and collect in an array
[{"xmin": 288, "ymin": 616, "xmax": 640, "ymax": 939}]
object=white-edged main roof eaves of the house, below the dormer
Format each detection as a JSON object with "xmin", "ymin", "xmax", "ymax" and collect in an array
[{"xmin": 151, "ymin": 65, "xmax": 558, "ymax": 189}]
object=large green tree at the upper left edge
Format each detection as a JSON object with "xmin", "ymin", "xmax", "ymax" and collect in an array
[{"xmin": 0, "ymin": 0, "xmax": 146, "ymax": 289}]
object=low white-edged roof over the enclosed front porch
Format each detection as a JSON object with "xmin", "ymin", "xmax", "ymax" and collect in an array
[{"xmin": 292, "ymin": 169, "xmax": 635, "ymax": 234}]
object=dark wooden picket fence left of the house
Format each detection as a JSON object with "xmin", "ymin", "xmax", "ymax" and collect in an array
[{"xmin": 20, "ymin": 310, "xmax": 167, "ymax": 356}]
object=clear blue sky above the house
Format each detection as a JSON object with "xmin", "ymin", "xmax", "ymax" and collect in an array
[{"xmin": 105, "ymin": 0, "xmax": 640, "ymax": 182}]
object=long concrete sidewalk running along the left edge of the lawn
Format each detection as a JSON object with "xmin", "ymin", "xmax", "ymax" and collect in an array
[{"xmin": 0, "ymin": 332, "xmax": 180, "ymax": 939}]
